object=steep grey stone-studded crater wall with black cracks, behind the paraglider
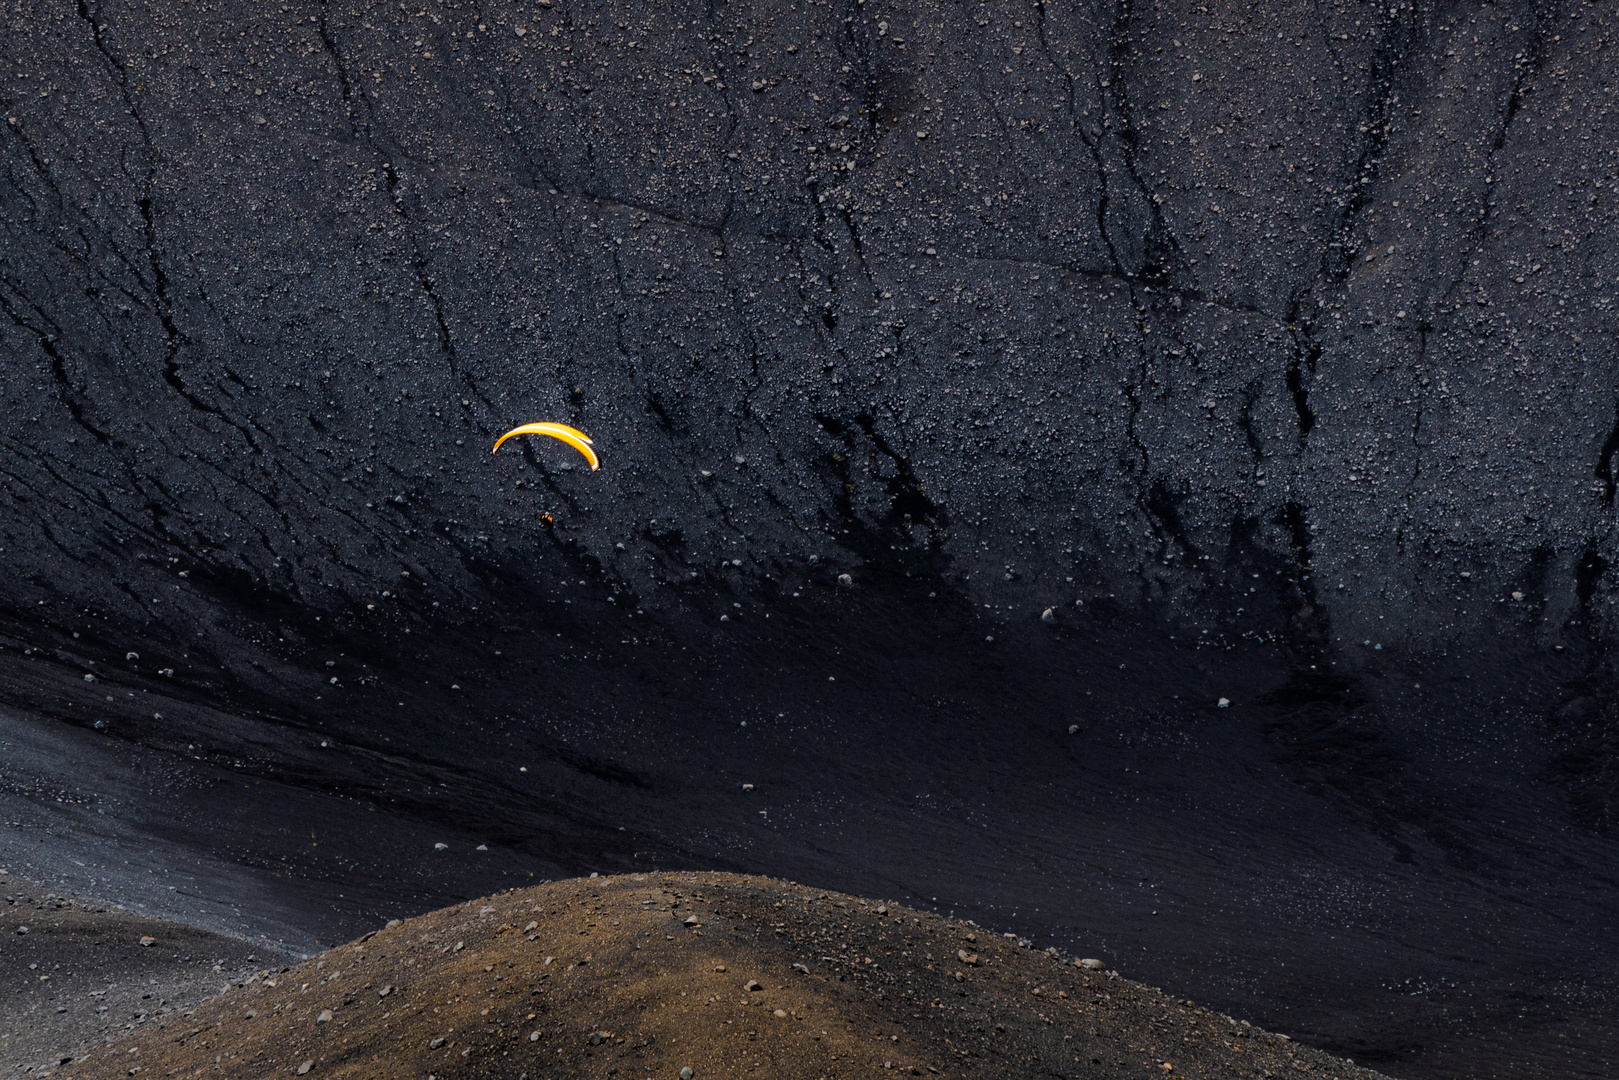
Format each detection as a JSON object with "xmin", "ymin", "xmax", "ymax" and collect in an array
[{"xmin": 0, "ymin": 0, "xmax": 1619, "ymax": 676}]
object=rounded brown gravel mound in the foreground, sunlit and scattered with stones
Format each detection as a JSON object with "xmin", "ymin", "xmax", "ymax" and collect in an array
[{"xmin": 58, "ymin": 873, "xmax": 1379, "ymax": 1080}]
